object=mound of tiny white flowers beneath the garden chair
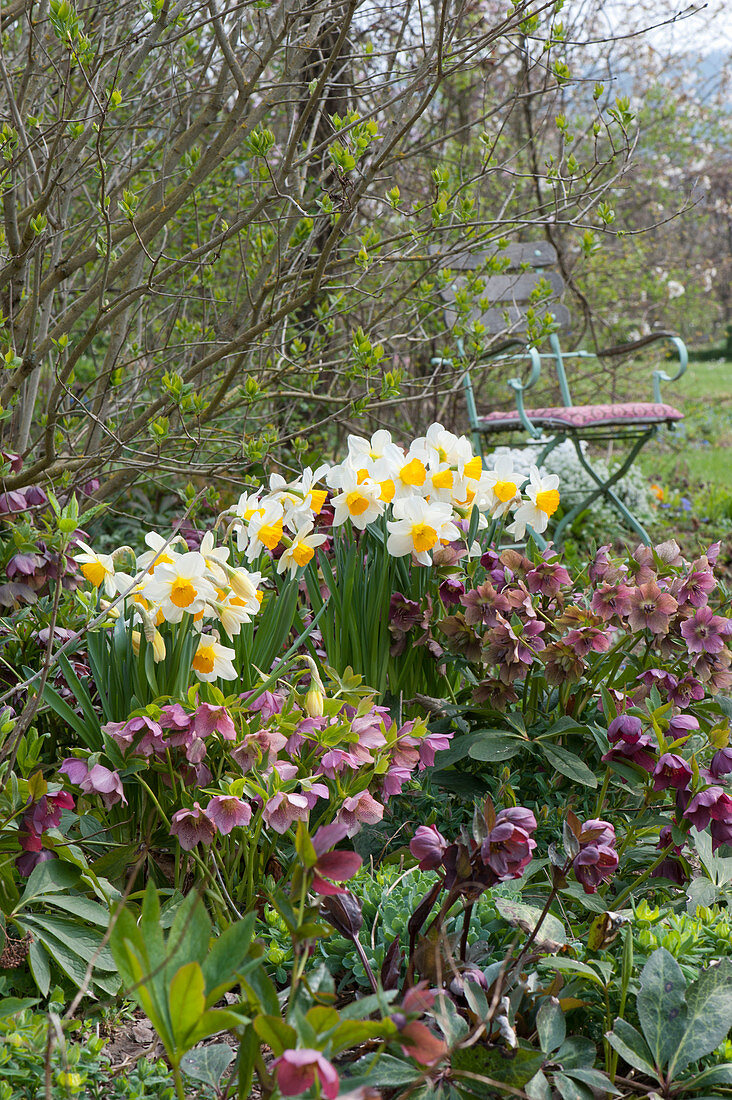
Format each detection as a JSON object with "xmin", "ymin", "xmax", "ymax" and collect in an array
[{"xmin": 488, "ymin": 439, "xmax": 654, "ymax": 532}]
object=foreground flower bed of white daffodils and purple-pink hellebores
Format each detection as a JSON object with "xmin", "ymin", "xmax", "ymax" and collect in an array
[{"xmin": 0, "ymin": 424, "xmax": 732, "ymax": 1100}]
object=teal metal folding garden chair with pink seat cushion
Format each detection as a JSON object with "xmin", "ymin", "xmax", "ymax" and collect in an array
[{"xmin": 433, "ymin": 244, "xmax": 688, "ymax": 545}]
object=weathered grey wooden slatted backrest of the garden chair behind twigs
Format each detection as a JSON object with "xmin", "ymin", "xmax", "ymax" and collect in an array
[{"xmin": 439, "ymin": 241, "xmax": 569, "ymax": 333}]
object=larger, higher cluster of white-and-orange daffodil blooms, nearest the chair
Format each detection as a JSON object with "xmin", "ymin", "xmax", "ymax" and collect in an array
[{"xmin": 230, "ymin": 424, "xmax": 559, "ymax": 558}]
